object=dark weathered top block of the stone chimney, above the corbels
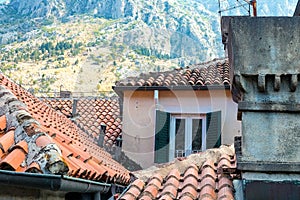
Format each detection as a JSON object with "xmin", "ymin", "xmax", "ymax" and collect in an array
[{"xmin": 223, "ymin": 17, "xmax": 300, "ymax": 75}]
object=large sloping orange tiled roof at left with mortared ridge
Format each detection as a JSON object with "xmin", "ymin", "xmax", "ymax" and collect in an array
[{"xmin": 0, "ymin": 73, "xmax": 130, "ymax": 184}]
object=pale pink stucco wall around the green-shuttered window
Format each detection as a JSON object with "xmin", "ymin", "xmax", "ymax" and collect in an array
[{"xmin": 122, "ymin": 90, "xmax": 241, "ymax": 168}]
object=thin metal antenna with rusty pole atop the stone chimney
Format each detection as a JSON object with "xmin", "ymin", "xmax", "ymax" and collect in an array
[{"xmin": 218, "ymin": 0, "xmax": 257, "ymax": 17}]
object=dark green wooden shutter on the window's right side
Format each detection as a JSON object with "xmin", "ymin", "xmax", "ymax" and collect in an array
[{"xmin": 206, "ymin": 111, "xmax": 221, "ymax": 149}]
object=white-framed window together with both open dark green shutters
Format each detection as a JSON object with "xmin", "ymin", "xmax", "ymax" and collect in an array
[{"xmin": 155, "ymin": 110, "xmax": 221, "ymax": 163}]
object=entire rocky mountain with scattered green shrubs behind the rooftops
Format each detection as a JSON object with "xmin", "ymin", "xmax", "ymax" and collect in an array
[{"xmin": 0, "ymin": 0, "xmax": 296, "ymax": 96}]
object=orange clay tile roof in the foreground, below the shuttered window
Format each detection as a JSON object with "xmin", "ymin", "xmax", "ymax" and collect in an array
[{"xmin": 121, "ymin": 146, "xmax": 235, "ymax": 200}]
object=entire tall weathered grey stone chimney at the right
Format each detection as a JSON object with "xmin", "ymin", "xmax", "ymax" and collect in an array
[{"xmin": 222, "ymin": 17, "xmax": 300, "ymax": 200}]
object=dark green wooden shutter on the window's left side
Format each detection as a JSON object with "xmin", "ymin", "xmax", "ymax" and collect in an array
[{"xmin": 154, "ymin": 110, "xmax": 170, "ymax": 163}]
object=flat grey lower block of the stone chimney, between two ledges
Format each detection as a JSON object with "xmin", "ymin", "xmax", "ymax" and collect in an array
[{"xmin": 242, "ymin": 112, "xmax": 300, "ymax": 162}]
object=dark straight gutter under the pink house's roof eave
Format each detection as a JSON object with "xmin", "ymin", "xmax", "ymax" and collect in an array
[{"xmin": 112, "ymin": 85, "xmax": 230, "ymax": 93}]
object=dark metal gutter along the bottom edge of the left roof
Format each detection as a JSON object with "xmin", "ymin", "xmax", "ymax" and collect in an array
[{"xmin": 0, "ymin": 170, "xmax": 111, "ymax": 194}]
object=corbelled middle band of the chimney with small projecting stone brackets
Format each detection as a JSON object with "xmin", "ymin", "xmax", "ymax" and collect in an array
[{"xmin": 233, "ymin": 74, "xmax": 300, "ymax": 112}]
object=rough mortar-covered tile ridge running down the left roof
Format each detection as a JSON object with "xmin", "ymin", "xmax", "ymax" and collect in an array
[{"xmin": 0, "ymin": 88, "xmax": 68, "ymax": 174}]
